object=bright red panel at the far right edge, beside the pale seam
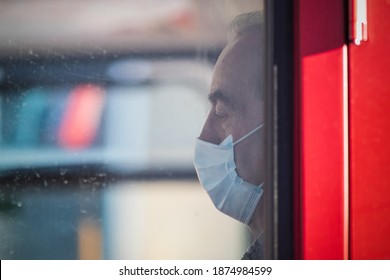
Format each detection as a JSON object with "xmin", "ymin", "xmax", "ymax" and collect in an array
[{"xmin": 349, "ymin": 0, "xmax": 390, "ymax": 259}]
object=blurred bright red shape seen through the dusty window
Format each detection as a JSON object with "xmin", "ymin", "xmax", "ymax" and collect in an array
[{"xmin": 58, "ymin": 85, "xmax": 105, "ymax": 149}]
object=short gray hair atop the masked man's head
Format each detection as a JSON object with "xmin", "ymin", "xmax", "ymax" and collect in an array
[{"xmin": 228, "ymin": 11, "xmax": 263, "ymax": 39}]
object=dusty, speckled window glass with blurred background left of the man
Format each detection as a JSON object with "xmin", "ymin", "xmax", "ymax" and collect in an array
[{"xmin": 0, "ymin": 0, "xmax": 263, "ymax": 259}]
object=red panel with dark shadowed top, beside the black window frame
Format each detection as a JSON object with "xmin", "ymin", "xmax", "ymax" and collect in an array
[{"xmin": 295, "ymin": 0, "xmax": 344, "ymax": 259}]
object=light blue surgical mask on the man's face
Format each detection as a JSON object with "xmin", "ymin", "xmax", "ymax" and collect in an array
[{"xmin": 194, "ymin": 125, "xmax": 263, "ymax": 224}]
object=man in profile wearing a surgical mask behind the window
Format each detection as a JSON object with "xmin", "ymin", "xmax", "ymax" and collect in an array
[{"xmin": 194, "ymin": 11, "xmax": 265, "ymax": 259}]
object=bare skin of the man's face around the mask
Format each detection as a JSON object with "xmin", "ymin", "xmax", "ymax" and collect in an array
[{"xmin": 199, "ymin": 34, "xmax": 264, "ymax": 185}]
